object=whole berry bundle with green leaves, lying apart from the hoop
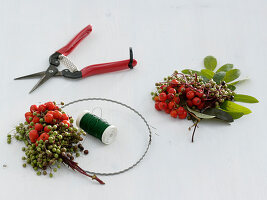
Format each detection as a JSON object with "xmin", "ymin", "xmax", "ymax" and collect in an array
[{"xmin": 151, "ymin": 56, "xmax": 258, "ymax": 142}]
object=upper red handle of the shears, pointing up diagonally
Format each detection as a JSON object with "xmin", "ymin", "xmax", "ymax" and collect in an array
[{"xmin": 57, "ymin": 25, "xmax": 92, "ymax": 56}]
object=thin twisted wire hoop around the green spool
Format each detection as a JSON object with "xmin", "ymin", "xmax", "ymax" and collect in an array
[{"xmin": 62, "ymin": 98, "xmax": 152, "ymax": 176}]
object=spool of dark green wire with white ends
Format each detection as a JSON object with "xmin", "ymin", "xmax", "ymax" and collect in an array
[{"xmin": 76, "ymin": 110, "xmax": 117, "ymax": 144}]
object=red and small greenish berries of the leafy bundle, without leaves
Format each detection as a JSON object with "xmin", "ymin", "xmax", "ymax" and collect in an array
[{"xmin": 151, "ymin": 71, "xmax": 236, "ymax": 119}]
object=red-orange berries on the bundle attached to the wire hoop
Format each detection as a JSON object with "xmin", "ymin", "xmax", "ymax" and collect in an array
[{"xmin": 25, "ymin": 102, "xmax": 70, "ymax": 143}]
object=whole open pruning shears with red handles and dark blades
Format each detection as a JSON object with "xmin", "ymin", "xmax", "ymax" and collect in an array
[{"xmin": 15, "ymin": 25, "xmax": 137, "ymax": 93}]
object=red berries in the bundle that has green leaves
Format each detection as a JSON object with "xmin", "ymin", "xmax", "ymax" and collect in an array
[{"xmin": 152, "ymin": 79, "xmax": 205, "ymax": 119}]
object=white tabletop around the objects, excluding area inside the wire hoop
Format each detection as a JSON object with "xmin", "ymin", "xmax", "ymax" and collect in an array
[{"xmin": 0, "ymin": 0, "xmax": 267, "ymax": 200}]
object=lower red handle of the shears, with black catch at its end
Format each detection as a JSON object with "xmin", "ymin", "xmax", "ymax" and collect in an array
[{"xmin": 81, "ymin": 59, "xmax": 137, "ymax": 78}]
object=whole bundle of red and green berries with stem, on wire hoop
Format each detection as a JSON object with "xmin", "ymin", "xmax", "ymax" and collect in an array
[{"xmin": 7, "ymin": 102, "xmax": 104, "ymax": 184}]
